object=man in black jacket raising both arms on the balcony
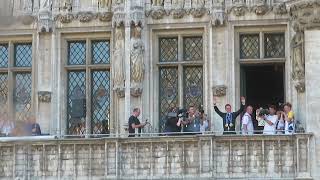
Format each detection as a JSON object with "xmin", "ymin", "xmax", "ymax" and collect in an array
[{"xmin": 213, "ymin": 96, "xmax": 246, "ymax": 134}]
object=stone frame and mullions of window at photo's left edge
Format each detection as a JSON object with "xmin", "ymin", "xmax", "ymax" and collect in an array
[{"xmin": 0, "ymin": 35, "xmax": 37, "ymax": 121}]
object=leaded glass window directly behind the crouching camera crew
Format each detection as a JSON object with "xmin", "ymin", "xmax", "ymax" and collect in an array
[{"xmin": 158, "ymin": 36, "xmax": 203, "ymax": 132}]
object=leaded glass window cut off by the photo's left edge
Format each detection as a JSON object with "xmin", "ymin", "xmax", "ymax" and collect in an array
[{"xmin": 0, "ymin": 41, "xmax": 32, "ymax": 122}]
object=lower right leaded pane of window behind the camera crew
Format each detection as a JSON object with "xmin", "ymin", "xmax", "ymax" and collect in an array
[{"xmin": 183, "ymin": 67, "xmax": 203, "ymax": 108}]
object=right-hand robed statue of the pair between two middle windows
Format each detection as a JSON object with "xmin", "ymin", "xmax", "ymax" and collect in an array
[{"xmin": 130, "ymin": 25, "xmax": 144, "ymax": 83}]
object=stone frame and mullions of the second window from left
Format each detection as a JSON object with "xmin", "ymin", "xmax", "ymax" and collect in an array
[{"xmin": 61, "ymin": 32, "xmax": 114, "ymax": 135}]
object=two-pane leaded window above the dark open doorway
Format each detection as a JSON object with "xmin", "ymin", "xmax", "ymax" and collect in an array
[{"xmin": 239, "ymin": 32, "xmax": 285, "ymax": 60}]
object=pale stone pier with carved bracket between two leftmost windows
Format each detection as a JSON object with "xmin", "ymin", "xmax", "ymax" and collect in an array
[{"xmin": 34, "ymin": 0, "xmax": 57, "ymax": 134}]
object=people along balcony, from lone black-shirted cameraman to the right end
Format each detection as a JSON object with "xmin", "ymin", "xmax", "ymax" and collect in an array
[{"xmin": 128, "ymin": 97, "xmax": 295, "ymax": 137}]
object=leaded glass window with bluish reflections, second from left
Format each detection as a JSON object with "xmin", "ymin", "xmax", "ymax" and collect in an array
[{"xmin": 66, "ymin": 39, "xmax": 111, "ymax": 135}]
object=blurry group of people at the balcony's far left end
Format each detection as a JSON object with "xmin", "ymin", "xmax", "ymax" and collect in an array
[{"xmin": 0, "ymin": 113, "xmax": 41, "ymax": 137}]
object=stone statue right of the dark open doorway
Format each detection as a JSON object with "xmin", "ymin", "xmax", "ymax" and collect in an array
[{"xmin": 291, "ymin": 25, "xmax": 305, "ymax": 80}]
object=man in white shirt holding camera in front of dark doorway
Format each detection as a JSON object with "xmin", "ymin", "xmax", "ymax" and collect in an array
[{"xmin": 263, "ymin": 105, "xmax": 278, "ymax": 134}]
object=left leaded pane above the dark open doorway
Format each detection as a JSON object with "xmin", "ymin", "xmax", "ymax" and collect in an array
[{"xmin": 240, "ymin": 34, "xmax": 260, "ymax": 59}]
